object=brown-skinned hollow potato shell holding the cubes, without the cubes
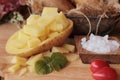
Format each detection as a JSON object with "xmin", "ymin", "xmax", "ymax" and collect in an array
[{"xmin": 6, "ymin": 20, "xmax": 73, "ymax": 57}]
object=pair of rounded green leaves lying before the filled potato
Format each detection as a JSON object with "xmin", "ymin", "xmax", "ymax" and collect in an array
[{"xmin": 35, "ymin": 52, "xmax": 68, "ymax": 74}]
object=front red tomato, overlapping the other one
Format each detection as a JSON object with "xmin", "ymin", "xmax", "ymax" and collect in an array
[{"xmin": 93, "ymin": 67, "xmax": 117, "ymax": 80}]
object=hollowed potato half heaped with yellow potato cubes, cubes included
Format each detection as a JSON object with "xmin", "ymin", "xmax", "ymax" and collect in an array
[{"xmin": 6, "ymin": 7, "xmax": 73, "ymax": 57}]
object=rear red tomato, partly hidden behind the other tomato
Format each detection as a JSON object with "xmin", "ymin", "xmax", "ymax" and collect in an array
[{"xmin": 90, "ymin": 59, "xmax": 109, "ymax": 73}]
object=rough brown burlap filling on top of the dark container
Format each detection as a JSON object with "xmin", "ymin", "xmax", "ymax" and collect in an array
[{"xmin": 68, "ymin": 0, "xmax": 120, "ymax": 16}]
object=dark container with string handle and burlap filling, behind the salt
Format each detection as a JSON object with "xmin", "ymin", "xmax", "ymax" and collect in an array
[{"xmin": 67, "ymin": 0, "xmax": 120, "ymax": 35}]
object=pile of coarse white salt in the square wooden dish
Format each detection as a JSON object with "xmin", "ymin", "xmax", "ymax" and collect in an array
[{"xmin": 81, "ymin": 34, "xmax": 120, "ymax": 54}]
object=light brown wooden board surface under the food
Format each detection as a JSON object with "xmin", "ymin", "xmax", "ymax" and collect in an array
[{"xmin": 0, "ymin": 24, "xmax": 120, "ymax": 80}]
